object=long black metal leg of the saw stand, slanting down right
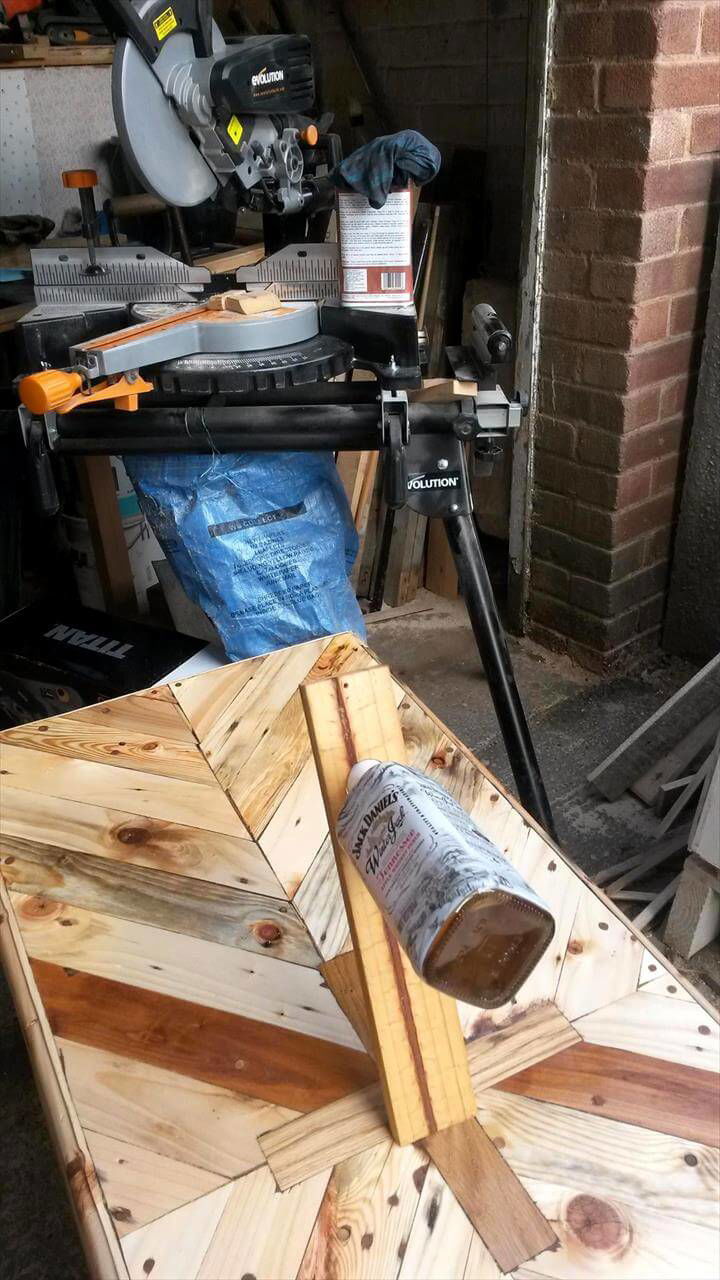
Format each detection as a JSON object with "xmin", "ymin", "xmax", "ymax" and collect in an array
[{"xmin": 443, "ymin": 516, "xmax": 557, "ymax": 840}]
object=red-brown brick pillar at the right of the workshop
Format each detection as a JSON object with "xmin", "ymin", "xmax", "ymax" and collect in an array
[{"xmin": 529, "ymin": 0, "xmax": 720, "ymax": 668}]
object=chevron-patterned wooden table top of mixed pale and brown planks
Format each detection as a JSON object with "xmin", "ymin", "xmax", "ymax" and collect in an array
[{"xmin": 0, "ymin": 635, "xmax": 720, "ymax": 1280}]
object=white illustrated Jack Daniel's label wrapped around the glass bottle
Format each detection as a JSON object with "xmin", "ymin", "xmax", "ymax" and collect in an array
[{"xmin": 337, "ymin": 764, "xmax": 547, "ymax": 974}]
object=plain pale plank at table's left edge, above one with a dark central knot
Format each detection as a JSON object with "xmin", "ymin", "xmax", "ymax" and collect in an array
[{"xmin": 0, "ymin": 742, "xmax": 247, "ymax": 837}]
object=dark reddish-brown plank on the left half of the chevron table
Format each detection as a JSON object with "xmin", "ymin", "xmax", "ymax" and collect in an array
[{"xmin": 32, "ymin": 960, "xmax": 377, "ymax": 1111}]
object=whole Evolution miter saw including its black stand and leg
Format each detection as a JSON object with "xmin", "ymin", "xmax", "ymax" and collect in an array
[{"xmin": 19, "ymin": 0, "xmax": 553, "ymax": 833}]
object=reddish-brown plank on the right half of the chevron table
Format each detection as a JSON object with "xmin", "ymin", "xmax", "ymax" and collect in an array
[{"xmin": 497, "ymin": 1042, "xmax": 720, "ymax": 1147}]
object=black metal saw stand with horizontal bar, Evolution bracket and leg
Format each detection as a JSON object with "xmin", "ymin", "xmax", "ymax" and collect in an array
[{"xmin": 35, "ymin": 372, "xmax": 555, "ymax": 837}]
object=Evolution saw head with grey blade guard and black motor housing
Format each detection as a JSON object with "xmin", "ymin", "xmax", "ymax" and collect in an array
[{"xmin": 99, "ymin": 0, "xmax": 322, "ymax": 215}]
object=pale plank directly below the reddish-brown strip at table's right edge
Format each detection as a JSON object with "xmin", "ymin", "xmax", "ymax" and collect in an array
[{"xmin": 478, "ymin": 1089, "xmax": 719, "ymax": 1226}]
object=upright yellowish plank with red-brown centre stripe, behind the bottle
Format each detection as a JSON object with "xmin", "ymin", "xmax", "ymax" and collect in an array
[{"xmin": 302, "ymin": 668, "xmax": 473, "ymax": 1146}]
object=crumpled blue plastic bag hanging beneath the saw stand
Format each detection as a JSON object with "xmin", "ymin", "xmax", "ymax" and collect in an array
[{"xmin": 123, "ymin": 453, "xmax": 365, "ymax": 660}]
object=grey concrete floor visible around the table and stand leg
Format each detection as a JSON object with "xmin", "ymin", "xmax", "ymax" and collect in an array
[{"xmin": 0, "ymin": 593, "xmax": 719, "ymax": 1280}]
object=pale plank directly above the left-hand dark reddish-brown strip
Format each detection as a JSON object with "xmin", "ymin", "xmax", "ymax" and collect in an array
[{"xmin": 12, "ymin": 893, "xmax": 361, "ymax": 1048}]
